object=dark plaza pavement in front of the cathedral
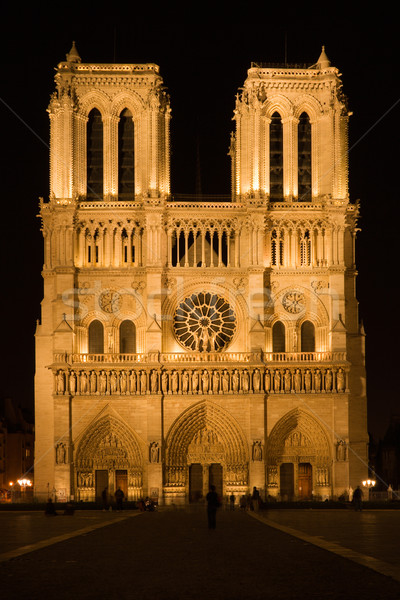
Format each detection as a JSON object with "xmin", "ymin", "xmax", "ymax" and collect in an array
[{"xmin": 0, "ymin": 507, "xmax": 400, "ymax": 600}]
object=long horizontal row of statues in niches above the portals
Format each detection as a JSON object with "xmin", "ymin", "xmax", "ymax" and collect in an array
[{"xmin": 56, "ymin": 368, "xmax": 346, "ymax": 395}]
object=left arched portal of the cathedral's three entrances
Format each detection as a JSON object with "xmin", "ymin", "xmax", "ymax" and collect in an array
[{"xmin": 74, "ymin": 415, "xmax": 143, "ymax": 500}]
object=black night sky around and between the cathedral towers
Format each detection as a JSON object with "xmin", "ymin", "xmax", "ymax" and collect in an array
[{"xmin": 0, "ymin": 10, "xmax": 400, "ymax": 436}]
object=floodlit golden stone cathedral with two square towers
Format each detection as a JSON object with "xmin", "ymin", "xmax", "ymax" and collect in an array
[{"xmin": 35, "ymin": 45, "xmax": 368, "ymax": 504}]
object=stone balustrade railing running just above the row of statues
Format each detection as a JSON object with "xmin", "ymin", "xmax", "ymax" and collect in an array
[{"xmin": 54, "ymin": 352, "xmax": 346, "ymax": 364}]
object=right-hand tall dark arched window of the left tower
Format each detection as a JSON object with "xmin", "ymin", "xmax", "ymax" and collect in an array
[{"xmin": 118, "ymin": 108, "xmax": 135, "ymax": 198}]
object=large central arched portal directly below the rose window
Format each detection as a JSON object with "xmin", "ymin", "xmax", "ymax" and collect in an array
[{"xmin": 164, "ymin": 400, "xmax": 249, "ymax": 502}]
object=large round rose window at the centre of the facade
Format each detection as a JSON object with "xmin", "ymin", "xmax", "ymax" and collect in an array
[{"xmin": 174, "ymin": 292, "xmax": 236, "ymax": 352}]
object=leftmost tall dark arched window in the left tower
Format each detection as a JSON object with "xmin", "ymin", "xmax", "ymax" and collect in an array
[{"xmin": 86, "ymin": 108, "xmax": 103, "ymax": 200}]
